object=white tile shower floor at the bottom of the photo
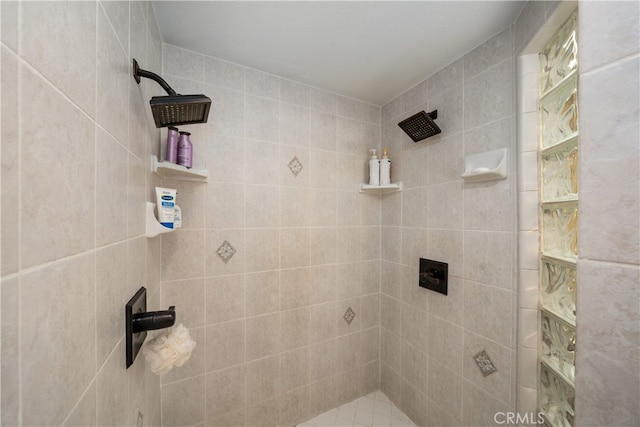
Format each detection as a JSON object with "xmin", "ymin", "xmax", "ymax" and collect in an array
[{"xmin": 297, "ymin": 390, "xmax": 415, "ymax": 427}]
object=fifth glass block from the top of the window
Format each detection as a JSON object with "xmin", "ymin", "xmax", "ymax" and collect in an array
[{"xmin": 540, "ymin": 258, "xmax": 576, "ymax": 325}]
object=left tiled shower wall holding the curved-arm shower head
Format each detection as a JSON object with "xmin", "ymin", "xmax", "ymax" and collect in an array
[{"xmin": 0, "ymin": 1, "xmax": 162, "ymax": 426}]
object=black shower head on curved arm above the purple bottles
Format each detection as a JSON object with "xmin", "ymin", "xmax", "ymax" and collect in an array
[{"xmin": 133, "ymin": 59, "xmax": 211, "ymax": 128}]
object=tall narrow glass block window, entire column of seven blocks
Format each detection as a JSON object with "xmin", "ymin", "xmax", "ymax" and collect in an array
[{"xmin": 538, "ymin": 8, "xmax": 579, "ymax": 427}]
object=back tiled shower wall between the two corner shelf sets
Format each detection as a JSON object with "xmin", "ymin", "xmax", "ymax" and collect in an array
[{"xmin": 161, "ymin": 44, "xmax": 380, "ymax": 426}]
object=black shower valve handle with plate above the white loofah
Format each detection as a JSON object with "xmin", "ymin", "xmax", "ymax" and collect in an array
[{"xmin": 125, "ymin": 286, "xmax": 176, "ymax": 368}]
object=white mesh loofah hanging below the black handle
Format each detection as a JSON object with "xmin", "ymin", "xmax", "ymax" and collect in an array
[{"xmin": 142, "ymin": 323, "xmax": 196, "ymax": 375}]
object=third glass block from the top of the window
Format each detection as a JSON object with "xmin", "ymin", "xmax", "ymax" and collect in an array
[{"xmin": 540, "ymin": 138, "xmax": 578, "ymax": 201}]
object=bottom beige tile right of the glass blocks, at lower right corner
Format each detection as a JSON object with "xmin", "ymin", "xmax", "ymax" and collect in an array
[{"xmin": 576, "ymin": 260, "xmax": 640, "ymax": 424}]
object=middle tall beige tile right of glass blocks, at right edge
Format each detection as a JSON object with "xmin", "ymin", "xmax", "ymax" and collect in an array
[{"xmin": 578, "ymin": 56, "xmax": 640, "ymax": 265}]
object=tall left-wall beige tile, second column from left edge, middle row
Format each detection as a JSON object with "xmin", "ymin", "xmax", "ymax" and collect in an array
[{"xmin": 20, "ymin": 67, "xmax": 95, "ymax": 267}]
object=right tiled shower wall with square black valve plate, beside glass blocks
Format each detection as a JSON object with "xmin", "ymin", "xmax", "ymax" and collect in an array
[{"xmin": 381, "ymin": 28, "xmax": 517, "ymax": 425}]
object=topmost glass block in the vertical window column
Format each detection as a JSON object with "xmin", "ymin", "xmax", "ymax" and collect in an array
[{"xmin": 538, "ymin": 13, "xmax": 578, "ymax": 94}]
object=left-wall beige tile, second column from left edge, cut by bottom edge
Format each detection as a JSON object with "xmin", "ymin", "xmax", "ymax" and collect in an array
[{"xmin": 20, "ymin": 254, "xmax": 96, "ymax": 425}]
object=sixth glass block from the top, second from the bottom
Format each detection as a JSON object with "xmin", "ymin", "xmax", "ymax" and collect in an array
[{"xmin": 540, "ymin": 310, "xmax": 576, "ymax": 383}]
